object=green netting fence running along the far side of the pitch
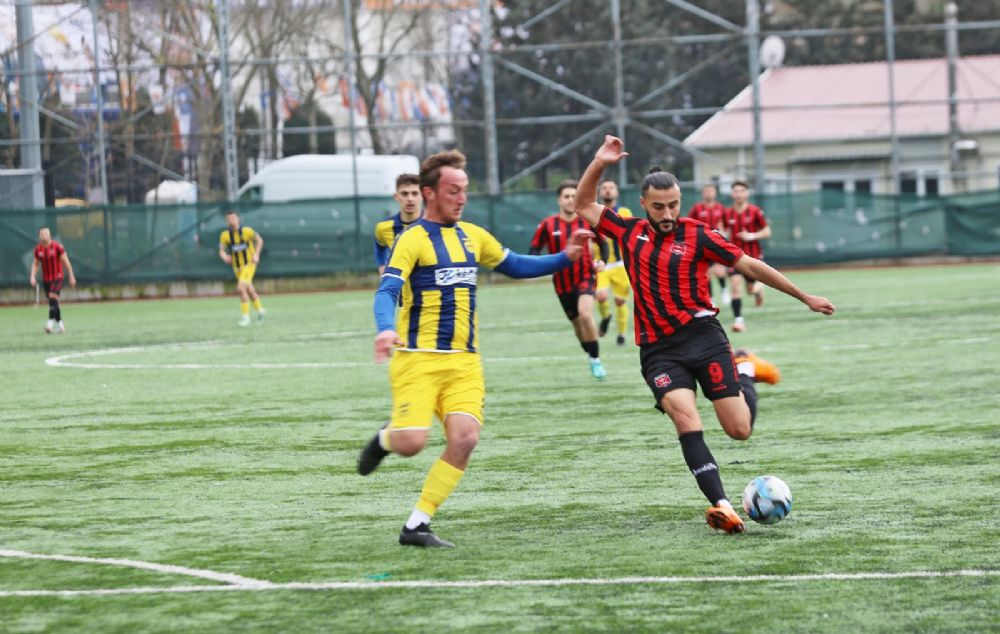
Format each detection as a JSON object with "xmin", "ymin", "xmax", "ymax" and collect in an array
[{"xmin": 0, "ymin": 188, "xmax": 1000, "ymax": 287}]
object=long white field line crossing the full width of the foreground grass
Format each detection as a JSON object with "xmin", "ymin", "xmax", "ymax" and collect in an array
[{"xmin": 0, "ymin": 570, "xmax": 1000, "ymax": 598}]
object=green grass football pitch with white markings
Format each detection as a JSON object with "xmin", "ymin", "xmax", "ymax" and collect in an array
[{"xmin": 0, "ymin": 263, "xmax": 1000, "ymax": 632}]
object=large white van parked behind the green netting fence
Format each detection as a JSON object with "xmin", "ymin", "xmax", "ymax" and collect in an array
[{"xmin": 239, "ymin": 154, "xmax": 420, "ymax": 202}]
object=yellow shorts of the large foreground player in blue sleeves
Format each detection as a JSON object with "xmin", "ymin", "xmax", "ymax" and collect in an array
[{"xmin": 389, "ymin": 351, "xmax": 486, "ymax": 429}]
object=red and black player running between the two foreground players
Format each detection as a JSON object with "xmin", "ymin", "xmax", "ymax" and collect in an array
[{"xmin": 528, "ymin": 180, "xmax": 607, "ymax": 379}]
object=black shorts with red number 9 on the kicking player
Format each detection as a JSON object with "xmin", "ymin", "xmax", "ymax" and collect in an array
[{"xmin": 639, "ymin": 317, "xmax": 741, "ymax": 411}]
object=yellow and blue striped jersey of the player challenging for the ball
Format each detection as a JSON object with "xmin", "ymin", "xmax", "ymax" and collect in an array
[{"xmin": 385, "ymin": 220, "xmax": 507, "ymax": 352}]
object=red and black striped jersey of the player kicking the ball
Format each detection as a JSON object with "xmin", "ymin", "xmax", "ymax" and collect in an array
[{"xmin": 597, "ymin": 207, "xmax": 743, "ymax": 345}]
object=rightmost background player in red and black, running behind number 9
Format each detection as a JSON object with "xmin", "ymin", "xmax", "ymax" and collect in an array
[{"xmin": 726, "ymin": 181, "xmax": 771, "ymax": 332}]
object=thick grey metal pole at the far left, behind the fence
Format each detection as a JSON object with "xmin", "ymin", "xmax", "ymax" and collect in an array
[{"xmin": 16, "ymin": 0, "xmax": 45, "ymax": 209}]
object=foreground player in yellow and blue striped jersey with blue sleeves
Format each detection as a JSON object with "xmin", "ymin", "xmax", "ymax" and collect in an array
[{"xmin": 358, "ymin": 150, "xmax": 593, "ymax": 547}]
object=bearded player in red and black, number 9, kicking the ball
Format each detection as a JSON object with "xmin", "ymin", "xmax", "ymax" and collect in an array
[{"xmin": 576, "ymin": 135, "xmax": 834, "ymax": 533}]
